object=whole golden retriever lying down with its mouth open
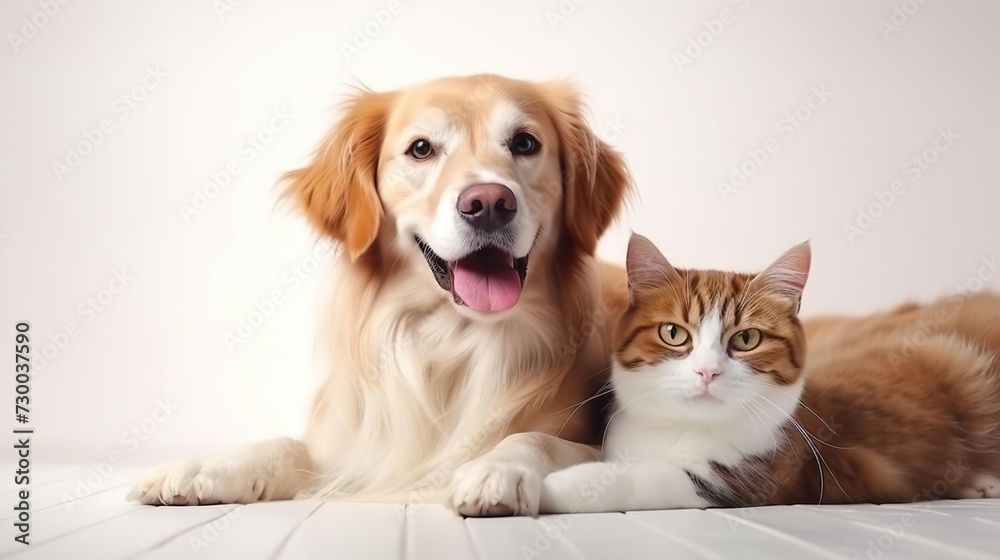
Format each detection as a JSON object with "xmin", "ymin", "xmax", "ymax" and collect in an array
[{"xmin": 130, "ymin": 75, "xmax": 631, "ymax": 516}]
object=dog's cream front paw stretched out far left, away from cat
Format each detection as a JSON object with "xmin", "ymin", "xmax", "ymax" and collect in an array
[{"xmin": 126, "ymin": 461, "xmax": 269, "ymax": 506}]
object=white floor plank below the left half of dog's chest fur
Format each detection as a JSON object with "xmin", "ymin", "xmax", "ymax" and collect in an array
[{"xmin": 276, "ymin": 502, "xmax": 405, "ymax": 560}]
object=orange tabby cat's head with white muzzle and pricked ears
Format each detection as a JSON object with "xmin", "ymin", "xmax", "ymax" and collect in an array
[{"xmin": 614, "ymin": 234, "xmax": 811, "ymax": 424}]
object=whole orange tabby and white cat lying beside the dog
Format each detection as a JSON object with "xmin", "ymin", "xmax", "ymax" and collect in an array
[{"xmin": 541, "ymin": 234, "xmax": 1000, "ymax": 513}]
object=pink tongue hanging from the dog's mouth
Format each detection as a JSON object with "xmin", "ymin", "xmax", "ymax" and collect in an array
[{"xmin": 453, "ymin": 248, "xmax": 521, "ymax": 311}]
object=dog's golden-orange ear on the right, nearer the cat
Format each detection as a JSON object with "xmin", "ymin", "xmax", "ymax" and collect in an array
[{"xmin": 544, "ymin": 83, "xmax": 632, "ymax": 254}]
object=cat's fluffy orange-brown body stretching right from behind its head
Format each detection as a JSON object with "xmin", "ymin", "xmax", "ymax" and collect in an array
[{"xmin": 765, "ymin": 292, "xmax": 1000, "ymax": 503}]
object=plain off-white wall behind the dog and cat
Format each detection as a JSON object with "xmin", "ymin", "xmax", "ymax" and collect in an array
[{"xmin": 0, "ymin": 0, "xmax": 1000, "ymax": 472}]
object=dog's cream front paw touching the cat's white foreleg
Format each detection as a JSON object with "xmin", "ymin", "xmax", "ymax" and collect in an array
[{"xmin": 449, "ymin": 460, "xmax": 542, "ymax": 517}]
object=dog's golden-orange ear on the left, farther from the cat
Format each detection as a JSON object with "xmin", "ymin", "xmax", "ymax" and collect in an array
[{"xmin": 282, "ymin": 91, "xmax": 395, "ymax": 260}]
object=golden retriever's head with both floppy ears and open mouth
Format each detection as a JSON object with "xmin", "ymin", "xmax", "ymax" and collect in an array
[{"xmin": 287, "ymin": 75, "xmax": 629, "ymax": 316}]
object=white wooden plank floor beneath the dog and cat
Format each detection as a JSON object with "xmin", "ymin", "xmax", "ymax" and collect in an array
[{"xmin": 0, "ymin": 467, "xmax": 1000, "ymax": 560}]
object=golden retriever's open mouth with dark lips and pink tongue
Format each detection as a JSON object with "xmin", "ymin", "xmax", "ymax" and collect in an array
[{"xmin": 417, "ymin": 237, "xmax": 528, "ymax": 311}]
